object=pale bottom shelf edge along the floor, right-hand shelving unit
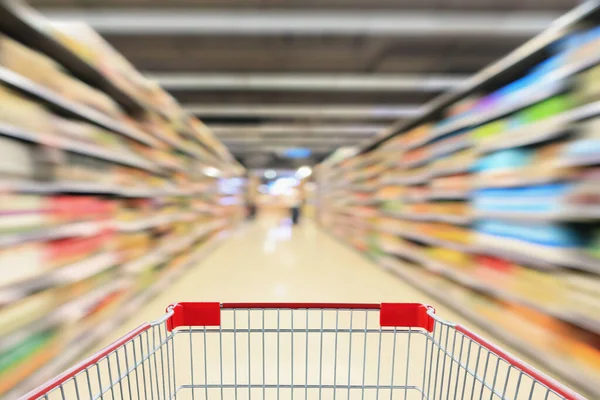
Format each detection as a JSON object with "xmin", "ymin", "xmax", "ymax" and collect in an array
[{"xmin": 379, "ymin": 258, "xmax": 600, "ymax": 397}]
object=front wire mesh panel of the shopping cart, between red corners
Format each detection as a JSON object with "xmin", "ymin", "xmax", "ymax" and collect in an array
[{"xmin": 175, "ymin": 309, "xmax": 426, "ymax": 399}]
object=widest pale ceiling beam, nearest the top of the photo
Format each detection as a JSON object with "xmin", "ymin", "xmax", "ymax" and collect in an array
[{"xmin": 42, "ymin": 8, "xmax": 560, "ymax": 36}]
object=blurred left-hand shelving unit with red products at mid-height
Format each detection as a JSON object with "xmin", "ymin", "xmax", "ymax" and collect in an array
[{"xmin": 0, "ymin": 1, "xmax": 244, "ymax": 398}]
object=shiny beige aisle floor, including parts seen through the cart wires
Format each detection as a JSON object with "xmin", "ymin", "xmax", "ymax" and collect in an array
[{"xmin": 54, "ymin": 215, "xmax": 576, "ymax": 400}]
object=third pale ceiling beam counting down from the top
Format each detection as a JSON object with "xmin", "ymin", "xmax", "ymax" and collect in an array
[{"xmin": 183, "ymin": 104, "xmax": 422, "ymax": 120}]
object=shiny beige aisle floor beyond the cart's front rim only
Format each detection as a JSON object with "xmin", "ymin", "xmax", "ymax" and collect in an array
[{"xmin": 99, "ymin": 215, "xmax": 459, "ymax": 336}]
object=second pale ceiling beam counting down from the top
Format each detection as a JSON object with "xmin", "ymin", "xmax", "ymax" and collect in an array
[{"xmin": 144, "ymin": 73, "xmax": 468, "ymax": 92}]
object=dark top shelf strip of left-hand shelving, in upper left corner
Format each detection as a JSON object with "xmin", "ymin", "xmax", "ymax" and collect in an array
[{"xmin": 0, "ymin": 0, "xmax": 146, "ymax": 115}]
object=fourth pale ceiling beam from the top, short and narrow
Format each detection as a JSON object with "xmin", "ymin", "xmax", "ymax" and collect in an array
[{"xmin": 208, "ymin": 124, "xmax": 388, "ymax": 136}]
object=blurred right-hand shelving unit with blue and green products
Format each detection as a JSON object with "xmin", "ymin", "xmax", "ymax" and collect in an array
[{"xmin": 318, "ymin": 2, "xmax": 600, "ymax": 398}]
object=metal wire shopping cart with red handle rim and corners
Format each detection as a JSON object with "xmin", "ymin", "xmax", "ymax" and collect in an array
[{"xmin": 23, "ymin": 303, "xmax": 583, "ymax": 400}]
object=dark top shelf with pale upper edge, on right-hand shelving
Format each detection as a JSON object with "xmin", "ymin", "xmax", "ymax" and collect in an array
[{"xmin": 360, "ymin": 0, "xmax": 600, "ymax": 153}]
